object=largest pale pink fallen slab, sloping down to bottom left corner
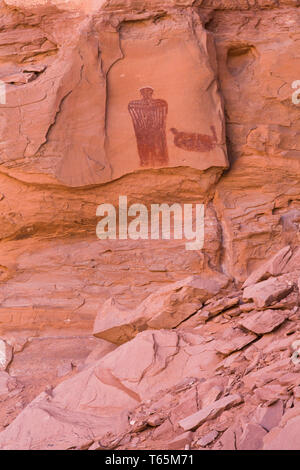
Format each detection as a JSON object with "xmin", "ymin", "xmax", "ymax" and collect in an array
[{"xmin": 0, "ymin": 330, "xmax": 218, "ymax": 450}]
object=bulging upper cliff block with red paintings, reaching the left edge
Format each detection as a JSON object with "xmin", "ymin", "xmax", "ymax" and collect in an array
[{"xmin": 0, "ymin": 6, "xmax": 228, "ymax": 187}]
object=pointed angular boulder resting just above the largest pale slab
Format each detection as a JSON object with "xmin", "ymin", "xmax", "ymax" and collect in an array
[{"xmin": 93, "ymin": 273, "xmax": 228, "ymax": 344}]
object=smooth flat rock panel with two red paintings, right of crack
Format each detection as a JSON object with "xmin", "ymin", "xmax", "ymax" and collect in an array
[{"xmin": 106, "ymin": 12, "xmax": 227, "ymax": 178}]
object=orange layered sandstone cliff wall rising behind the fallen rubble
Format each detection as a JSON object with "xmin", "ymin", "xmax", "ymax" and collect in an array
[{"xmin": 0, "ymin": 0, "xmax": 300, "ymax": 448}]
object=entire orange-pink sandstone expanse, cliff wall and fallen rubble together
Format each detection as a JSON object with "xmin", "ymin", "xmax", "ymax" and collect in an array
[{"xmin": 0, "ymin": 0, "xmax": 300, "ymax": 449}]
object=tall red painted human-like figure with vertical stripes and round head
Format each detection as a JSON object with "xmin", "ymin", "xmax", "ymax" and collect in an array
[{"xmin": 128, "ymin": 87, "xmax": 169, "ymax": 167}]
